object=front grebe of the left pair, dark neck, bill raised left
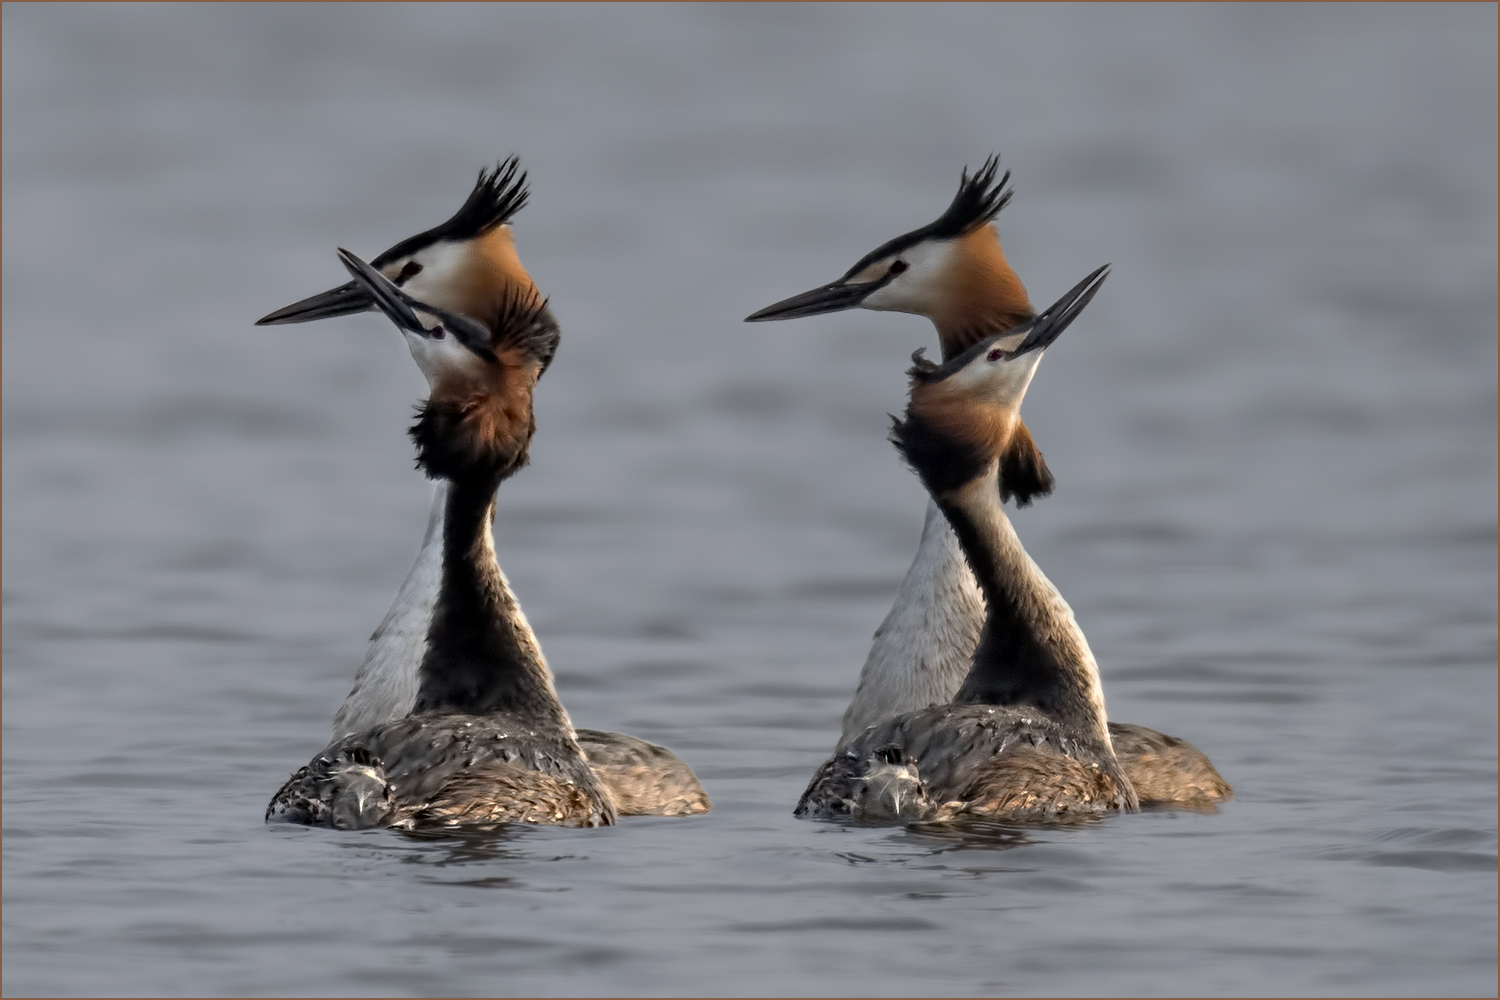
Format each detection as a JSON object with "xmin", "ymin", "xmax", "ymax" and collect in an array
[{"xmin": 266, "ymin": 250, "xmax": 615, "ymax": 829}]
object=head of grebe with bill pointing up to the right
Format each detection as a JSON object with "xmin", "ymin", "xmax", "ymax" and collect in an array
[{"xmin": 891, "ymin": 264, "xmax": 1109, "ymax": 505}]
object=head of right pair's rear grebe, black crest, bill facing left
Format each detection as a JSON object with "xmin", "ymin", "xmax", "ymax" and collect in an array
[{"xmin": 746, "ymin": 156, "xmax": 1032, "ymax": 340}]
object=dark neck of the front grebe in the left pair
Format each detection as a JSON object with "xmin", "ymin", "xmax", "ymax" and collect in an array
[{"xmin": 416, "ymin": 471, "xmax": 569, "ymax": 727}]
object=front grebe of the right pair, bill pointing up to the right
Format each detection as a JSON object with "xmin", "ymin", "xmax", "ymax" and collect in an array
[{"xmin": 797, "ymin": 268, "xmax": 1139, "ymax": 823}]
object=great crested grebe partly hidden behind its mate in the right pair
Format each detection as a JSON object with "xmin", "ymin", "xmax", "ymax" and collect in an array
[{"xmin": 746, "ymin": 156, "xmax": 1230, "ymax": 807}]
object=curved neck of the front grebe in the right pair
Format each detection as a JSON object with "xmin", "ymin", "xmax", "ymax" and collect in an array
[{"xmin": 936, "ymin": 463, "xmax": 1109, "ymax": 747}]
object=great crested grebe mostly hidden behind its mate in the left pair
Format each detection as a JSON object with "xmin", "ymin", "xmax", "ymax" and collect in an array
[{"xmin": 257, "ymin": 166, "xmax": 710, "ymax": 816}]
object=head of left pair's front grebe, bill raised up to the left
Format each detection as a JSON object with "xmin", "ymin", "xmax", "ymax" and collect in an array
[{"xmin": 339, "ymin": 250, "xmax": 558, "ymax": 480}]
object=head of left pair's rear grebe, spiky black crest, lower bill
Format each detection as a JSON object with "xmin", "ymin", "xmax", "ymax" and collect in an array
[{"xmin": 255, "ymin": 156, "xmax": 540, "ymax": 328}]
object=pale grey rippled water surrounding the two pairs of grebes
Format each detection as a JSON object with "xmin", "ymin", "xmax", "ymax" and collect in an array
[{"xmin": 3, "ymin": 4, "xmax": 1497, "ymax": 996}]
